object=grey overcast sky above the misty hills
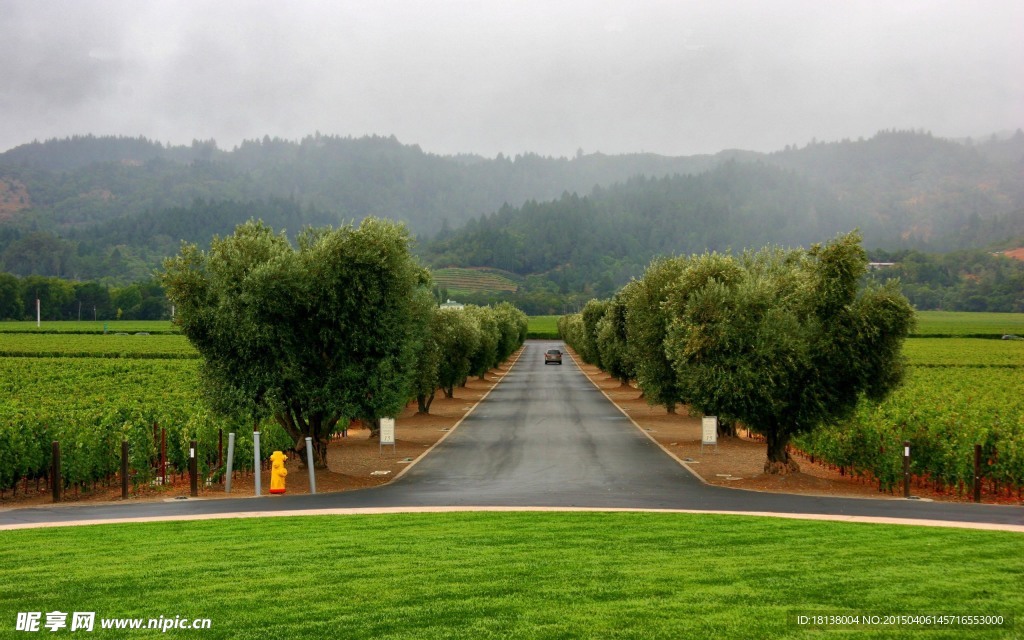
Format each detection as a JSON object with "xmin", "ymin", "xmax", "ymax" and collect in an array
[{"xmin": 0, "ymin": 0, "xmax": 1024, "ymax": 157}]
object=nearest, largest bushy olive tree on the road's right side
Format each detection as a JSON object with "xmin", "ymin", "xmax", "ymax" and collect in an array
[{"xmin": 665, "ymin": 232, "xmax": 913, "ymax": 473}]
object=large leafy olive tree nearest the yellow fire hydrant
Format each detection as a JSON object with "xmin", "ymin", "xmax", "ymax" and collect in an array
[{"xmin": 162, "ymin": 218, "xmax": 428, "ymax": 467}]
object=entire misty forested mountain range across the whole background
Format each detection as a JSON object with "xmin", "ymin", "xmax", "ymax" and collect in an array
[{"xmin": 0, "ymin": 131, "xmax": 1024, "ymax": 290}]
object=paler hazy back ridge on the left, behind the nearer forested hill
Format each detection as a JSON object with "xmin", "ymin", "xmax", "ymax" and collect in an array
[{"xmin": 0, "ymin": 134, "xmax": 738, "ymax": 236}]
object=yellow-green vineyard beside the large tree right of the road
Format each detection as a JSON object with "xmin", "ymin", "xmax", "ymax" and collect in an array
[{"xmin": 795, "ymin": 333, "xmax": 1024, "ymax": 499}]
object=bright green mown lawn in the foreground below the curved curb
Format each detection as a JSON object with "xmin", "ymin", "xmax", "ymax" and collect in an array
[{"xmin": 0, "ymin": 513, "xmax": 1024, "ymax": 639}]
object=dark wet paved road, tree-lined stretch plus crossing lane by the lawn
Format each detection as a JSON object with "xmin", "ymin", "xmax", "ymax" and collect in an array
[{"xmin": 0, "ymin": 341, "xmax": 1024, "ymax": 525}]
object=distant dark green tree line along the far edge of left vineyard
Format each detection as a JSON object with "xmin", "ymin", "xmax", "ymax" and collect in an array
[{"xmin": 0, "ymin": 273, "xmax": 170, "ymax": 321}]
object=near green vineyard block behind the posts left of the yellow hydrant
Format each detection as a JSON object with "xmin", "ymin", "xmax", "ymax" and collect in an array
[{"xmin": 0, "ymin": 354, "xmax": 292, "ymax": 497}]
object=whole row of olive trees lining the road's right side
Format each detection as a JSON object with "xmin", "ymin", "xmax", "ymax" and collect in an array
[{"xmin": 559, "ymin": 232, "xmax": 913, "ymax": 473}]
